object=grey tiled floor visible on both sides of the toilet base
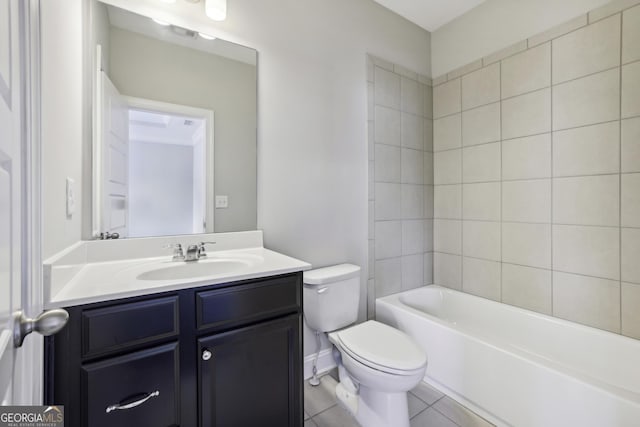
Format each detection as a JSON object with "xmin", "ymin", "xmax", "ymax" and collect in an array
[{"xmin": 304, "ymin": 372, "xmax": 493, "ymax": 427}]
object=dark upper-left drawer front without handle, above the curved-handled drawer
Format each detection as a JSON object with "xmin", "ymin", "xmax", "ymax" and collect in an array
[{"xmin": 82, "ymin": 295, "xmax": 178, "ymax": 358}]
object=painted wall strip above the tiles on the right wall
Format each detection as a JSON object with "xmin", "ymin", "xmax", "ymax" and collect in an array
[{"xmin": 431, "ymin": 0, "xmax": 610, "ymax": 77}]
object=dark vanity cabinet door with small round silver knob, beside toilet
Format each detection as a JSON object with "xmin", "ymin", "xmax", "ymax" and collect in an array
[{"xmin": 198, "ymin": 314, "xmax": 303, "ymax": 427}]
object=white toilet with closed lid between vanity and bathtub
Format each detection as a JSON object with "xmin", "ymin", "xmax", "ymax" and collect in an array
[{"xmin": 303, "ymin": 264, "xmax": 427, "ymax": 427}]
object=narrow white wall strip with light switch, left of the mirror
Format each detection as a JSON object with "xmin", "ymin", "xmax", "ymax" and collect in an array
[{"xmin": 41, "ymin": 0, "xmax": 84, "ymax": 259}]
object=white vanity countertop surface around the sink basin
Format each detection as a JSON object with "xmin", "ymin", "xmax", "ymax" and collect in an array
[{"xmin": 45, "ymin": 236, "xmax": 311, "ymax": 309}]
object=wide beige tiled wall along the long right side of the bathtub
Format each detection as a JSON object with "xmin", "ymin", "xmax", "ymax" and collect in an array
[{"xmin": 430, "ymin": 0, "xmax": 640, "ymax": 338}]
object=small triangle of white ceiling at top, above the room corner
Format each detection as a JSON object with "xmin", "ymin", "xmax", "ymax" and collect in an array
[{"xmin": 374, "ymin": 0, "xmax": 485, "ymax": 32}]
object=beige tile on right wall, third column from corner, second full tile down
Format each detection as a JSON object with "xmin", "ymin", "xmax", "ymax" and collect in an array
[{"xmin": 502, "ymin": 89, "xmax": 551, "ymax": 139}]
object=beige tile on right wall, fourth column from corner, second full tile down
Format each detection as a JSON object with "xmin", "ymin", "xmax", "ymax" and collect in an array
[{"xmin": 553, "ymin": 69, "xmax": 620, "ymax": 130}]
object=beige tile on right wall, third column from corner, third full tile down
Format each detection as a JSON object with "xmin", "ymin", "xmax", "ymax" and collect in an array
[{"xmin": 502, "ymin": 133, "xmax": 551, "ymax": 180}]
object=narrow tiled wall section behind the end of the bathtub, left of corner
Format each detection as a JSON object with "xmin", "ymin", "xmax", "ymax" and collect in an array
[{"xmin": 367, "ymin": 56, "xmax": 433, "ymax": 318}]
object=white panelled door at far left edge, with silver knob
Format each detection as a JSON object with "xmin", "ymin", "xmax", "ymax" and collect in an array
[{"xmin": 0, "ymin": 0, "xmax": 39, "ymax": 404}]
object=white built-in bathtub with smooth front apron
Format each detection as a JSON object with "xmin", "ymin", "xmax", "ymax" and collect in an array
[{"xmin": 376, "ymin": 286, "xmax": 640, "ymax": 427}]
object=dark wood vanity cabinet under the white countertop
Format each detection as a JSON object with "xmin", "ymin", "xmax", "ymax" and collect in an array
[{"xmin": 44, "ymin": 273, "xmax": 303, "ymax": 427}]
